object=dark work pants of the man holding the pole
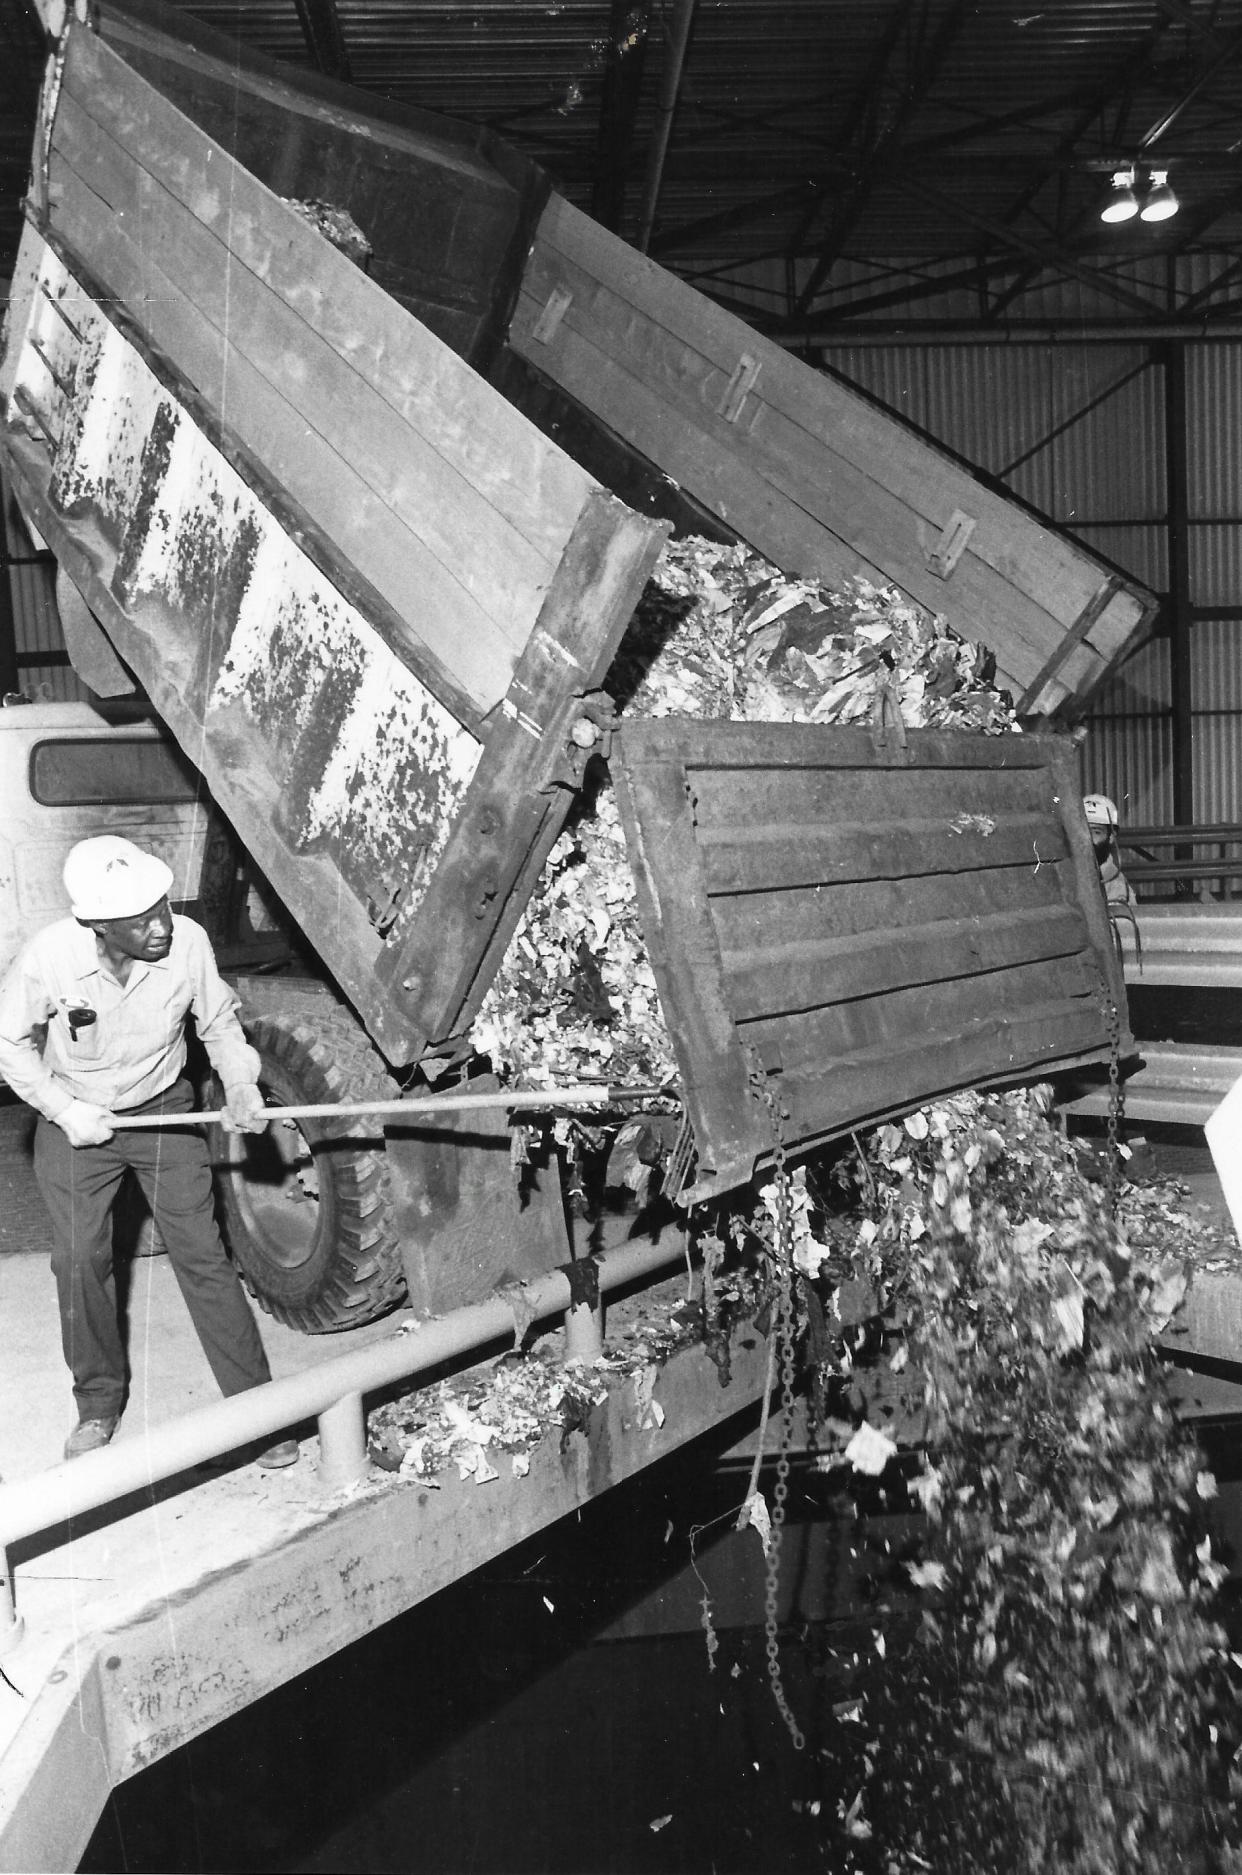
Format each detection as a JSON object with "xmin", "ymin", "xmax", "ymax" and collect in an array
[{"xmin": 34, "ymin": 1082, "xmax": 272, "ymax": 1419}]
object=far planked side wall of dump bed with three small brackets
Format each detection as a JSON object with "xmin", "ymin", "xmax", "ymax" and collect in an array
[{"xmin": 508, "ymin": 195, "xmax": 1154, "ymax": 714}]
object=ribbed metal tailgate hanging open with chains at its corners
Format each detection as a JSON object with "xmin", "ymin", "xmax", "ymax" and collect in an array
[{"xmin": 613, "ymin": 718, "xmax": 1131, "ymax": 1198}]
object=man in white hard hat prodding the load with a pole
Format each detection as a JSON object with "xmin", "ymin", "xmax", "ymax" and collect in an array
[{"xmin": 0, "ymin": 834, "xmax": 298, "ymax": 1466}]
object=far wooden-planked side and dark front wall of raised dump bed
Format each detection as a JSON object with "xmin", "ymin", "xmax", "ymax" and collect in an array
[{"xmin": 77, "ymin": 0, "xmax": 1156, "ymax": 714}]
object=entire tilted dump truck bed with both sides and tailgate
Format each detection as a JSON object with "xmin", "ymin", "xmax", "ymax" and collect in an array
[{"xmin": 0, "ymin": 6, "xmax": 1150, "ymax": 1185}]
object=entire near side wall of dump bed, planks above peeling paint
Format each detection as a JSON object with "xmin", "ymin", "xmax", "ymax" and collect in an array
[{"xmin": 6, "ymin": 14, "xmax": 664, "ymax": 1061}]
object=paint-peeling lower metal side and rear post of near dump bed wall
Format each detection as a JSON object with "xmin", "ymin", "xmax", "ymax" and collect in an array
[{"xmin": 4, "ymin": 182, "xmax": 662, "ymax": 1061}]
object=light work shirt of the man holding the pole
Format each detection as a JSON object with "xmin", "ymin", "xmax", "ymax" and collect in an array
[{"xmin": 0, "ymin": 913, "xmax": 259, "ymax": 1119}]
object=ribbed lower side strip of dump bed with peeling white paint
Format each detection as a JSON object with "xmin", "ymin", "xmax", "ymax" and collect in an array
[{"xmin": 8, "ymin": 231, "xmax": 480, "ymax": 1057}]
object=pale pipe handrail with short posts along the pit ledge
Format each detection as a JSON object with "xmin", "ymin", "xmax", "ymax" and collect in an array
[{"xmin": 0, "ymin": 1241, "xmax": 685, "ymax": 1654}]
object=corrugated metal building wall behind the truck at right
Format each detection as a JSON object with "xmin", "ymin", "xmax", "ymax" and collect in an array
[{"xmin": 824, "ymin": 339, "xmax": 1242, "ymax": 823}]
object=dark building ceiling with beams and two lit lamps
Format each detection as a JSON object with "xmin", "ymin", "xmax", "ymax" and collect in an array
[{"xmin": 0, "ymin": 0, "xmax": 1242, "ymax": 345}]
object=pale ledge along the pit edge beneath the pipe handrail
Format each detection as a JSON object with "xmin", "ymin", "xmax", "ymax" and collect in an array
[{"xmin": 0, "ymin": 1305, "xmax": 767, "ymax": 1875}]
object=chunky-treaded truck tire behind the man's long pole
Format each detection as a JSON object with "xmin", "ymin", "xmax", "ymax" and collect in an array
[{"xmin": 212, "ymin": 1009, "xmax": 405, "ymax": 1335}]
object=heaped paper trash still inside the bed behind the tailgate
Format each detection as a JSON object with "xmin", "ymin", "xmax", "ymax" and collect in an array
[{"xmin": 473, "ymin": 536, "xmax": 1015, "ymax": 1088}]
